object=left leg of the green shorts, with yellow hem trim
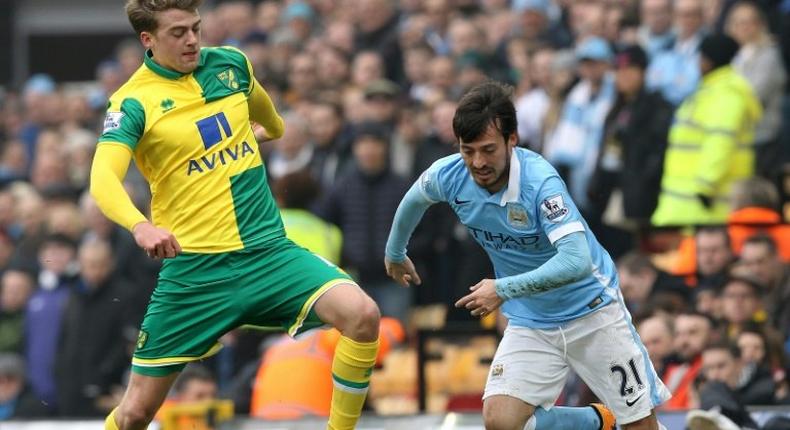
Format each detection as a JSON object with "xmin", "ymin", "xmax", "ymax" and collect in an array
[{"xmin": 132, "ymin": 254, "xmax": 239, "ymax": 376}]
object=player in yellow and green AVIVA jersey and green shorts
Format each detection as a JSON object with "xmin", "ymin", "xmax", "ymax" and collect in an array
[{"xmin": 91, "ymin": 0, "xmax": 379, "ymax": 430}]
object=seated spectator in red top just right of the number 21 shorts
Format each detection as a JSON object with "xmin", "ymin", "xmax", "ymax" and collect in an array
[{"xmin": 663, "ymin": 313, "xmax": 713, "ymax": 410}]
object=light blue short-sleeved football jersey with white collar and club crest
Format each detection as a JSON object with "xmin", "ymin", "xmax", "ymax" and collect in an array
[{"xmin": 419, "ymin": 148, "xmax": 619, "ymax": 328}]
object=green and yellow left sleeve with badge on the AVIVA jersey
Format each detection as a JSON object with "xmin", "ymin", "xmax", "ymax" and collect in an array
[{"xmin": 99, "ymin": 97, "xmax": 145, "ymax": 151}]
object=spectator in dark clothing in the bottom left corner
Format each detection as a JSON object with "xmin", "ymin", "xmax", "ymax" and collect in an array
[{"xmin": 0, "ymin": 353, "xmax": 51, "ymax": 421}]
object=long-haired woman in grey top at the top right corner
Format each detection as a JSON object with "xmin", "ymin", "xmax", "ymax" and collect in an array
[{"xmin": 727, "ymin": 1, "xmax": 787, "ymax": 180}]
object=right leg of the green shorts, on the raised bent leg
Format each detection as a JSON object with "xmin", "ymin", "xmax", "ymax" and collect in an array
[{"xmin": 240, "ymin": 239, "xmax": 354, "ymax": 336}]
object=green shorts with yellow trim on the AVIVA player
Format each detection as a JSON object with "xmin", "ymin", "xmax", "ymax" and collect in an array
[{"xmin": 132, "ymin": 238, "xmax": 353, "ymax": 376}]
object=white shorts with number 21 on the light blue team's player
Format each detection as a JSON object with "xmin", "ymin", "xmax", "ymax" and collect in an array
[{"xmin": 483, "ymin": 301, "xmax": 671, "ymax": 424}]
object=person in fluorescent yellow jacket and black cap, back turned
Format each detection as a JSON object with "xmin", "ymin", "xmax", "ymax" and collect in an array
[{"xmin": 652, "ymin": 35, "xmax": 762, "ymax": 226}]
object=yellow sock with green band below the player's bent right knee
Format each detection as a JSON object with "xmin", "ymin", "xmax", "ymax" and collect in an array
[{"xmin": 327, "ymin": 336, "xmax": 379, "ymax": 430}]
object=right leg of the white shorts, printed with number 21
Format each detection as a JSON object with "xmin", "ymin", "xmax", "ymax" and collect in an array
[{"xmin": 566, "ymin": 301, "xmax": 670, "ymax": 425}]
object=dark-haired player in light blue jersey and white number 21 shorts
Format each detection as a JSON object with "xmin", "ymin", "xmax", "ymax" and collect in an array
[{"xmin": 385, "ymin": 82, "xmax": 670, "ymax": 430}]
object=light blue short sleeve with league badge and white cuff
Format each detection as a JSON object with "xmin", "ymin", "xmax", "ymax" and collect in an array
[{"xmin": 537, "ymin": 176, "xmax": 585, "ymax": 243}]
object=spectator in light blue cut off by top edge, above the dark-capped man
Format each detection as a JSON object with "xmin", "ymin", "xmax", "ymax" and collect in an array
[{"xmin": 638, "ymin": 0, "xmax": 675, "ymax": 59}]
